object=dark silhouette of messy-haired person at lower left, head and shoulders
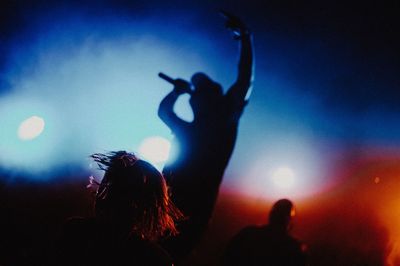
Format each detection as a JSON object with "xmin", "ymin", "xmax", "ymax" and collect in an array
[{"xmin": 51, "ymin": 151, "xmax": 183, "ymax": 266}]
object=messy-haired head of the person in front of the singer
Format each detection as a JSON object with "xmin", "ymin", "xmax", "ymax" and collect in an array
[{"xmin": 92, "ymin": 151, "xmax": 183, "ymax": 240}]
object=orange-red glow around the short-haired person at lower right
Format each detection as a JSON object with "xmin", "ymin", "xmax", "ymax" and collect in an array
[{"xmin": 219, "ymin": 148, "xmax": 400, "ymax": 266}]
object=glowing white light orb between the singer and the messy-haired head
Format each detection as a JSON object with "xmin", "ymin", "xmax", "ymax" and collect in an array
[{"xmin": 139, "ymin": 137, "xmax": 171, "ymax": 164}]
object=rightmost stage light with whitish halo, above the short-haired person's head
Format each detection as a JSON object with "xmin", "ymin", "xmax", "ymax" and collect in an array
[{"xmin": 232, "ymin": 137, "xmax": 334, "ymax": 200}]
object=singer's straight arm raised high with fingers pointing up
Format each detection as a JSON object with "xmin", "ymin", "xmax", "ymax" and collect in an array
[{"xmin": 221, "ymin": 12, "xmax": 254, "ymax": 104}]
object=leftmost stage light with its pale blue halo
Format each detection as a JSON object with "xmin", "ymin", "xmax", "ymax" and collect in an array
[{"xmin": 0, "ymin": 94, "xmax": 65, "ymax": 174}]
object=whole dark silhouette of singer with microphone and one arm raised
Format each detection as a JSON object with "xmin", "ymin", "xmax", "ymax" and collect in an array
[{"xmin": 158, "ymin": 12, "xmax": 253, "ymax": 256}]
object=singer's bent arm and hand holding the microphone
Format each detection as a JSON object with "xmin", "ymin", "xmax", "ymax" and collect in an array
[{"xmin": 158, "ymin": 79, "xmax": 190, "ymax": 131}]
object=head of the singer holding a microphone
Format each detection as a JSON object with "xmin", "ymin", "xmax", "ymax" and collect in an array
[{"xmin": 189, "ymin": 73, "xmax": 223, "ymax": 116}]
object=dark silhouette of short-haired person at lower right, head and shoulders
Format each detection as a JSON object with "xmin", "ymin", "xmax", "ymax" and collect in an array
[{"xmin": 223, "ymin": 199, "xmax": 306, "ymax": 266}]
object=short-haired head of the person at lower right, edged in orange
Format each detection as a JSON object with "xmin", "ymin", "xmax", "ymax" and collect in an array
[{"xmin": 269, "ymin": 199, "xmax": 295, "ymax": 230}]
